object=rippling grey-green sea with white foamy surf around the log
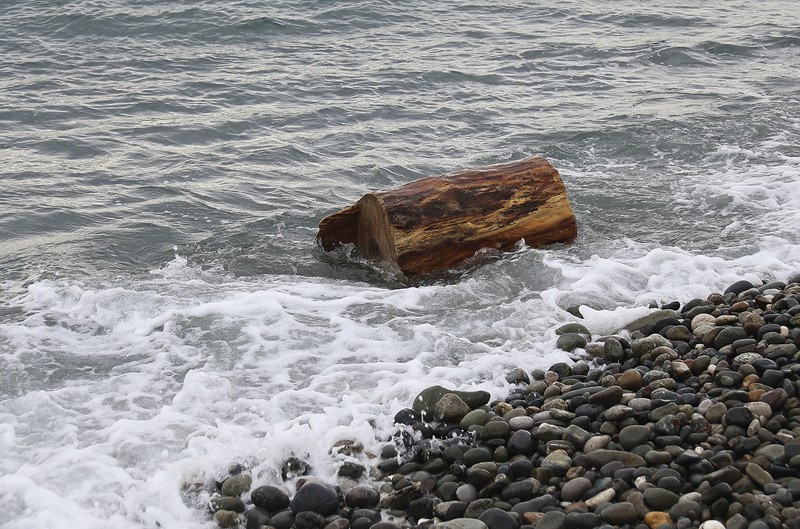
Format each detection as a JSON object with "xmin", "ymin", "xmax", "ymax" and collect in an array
[{"xmin": 0, "ymin": 0, "xmax": 800, "ymax": 529}]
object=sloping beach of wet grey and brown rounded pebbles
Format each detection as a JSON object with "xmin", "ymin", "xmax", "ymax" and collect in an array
[{"xmin": 194, "ymin": 275, "xmax": 800, "ymax": 529}]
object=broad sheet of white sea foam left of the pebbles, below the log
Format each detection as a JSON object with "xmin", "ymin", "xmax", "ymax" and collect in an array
[{"xmin": 0, "ymin": 266, "xmax": 552, "ymax": 527}]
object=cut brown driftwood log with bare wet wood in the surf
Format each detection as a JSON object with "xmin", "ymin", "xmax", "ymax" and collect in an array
[{"xmin": 317, "ymin": 157, "xmax": 577, "ymax": 275}]
